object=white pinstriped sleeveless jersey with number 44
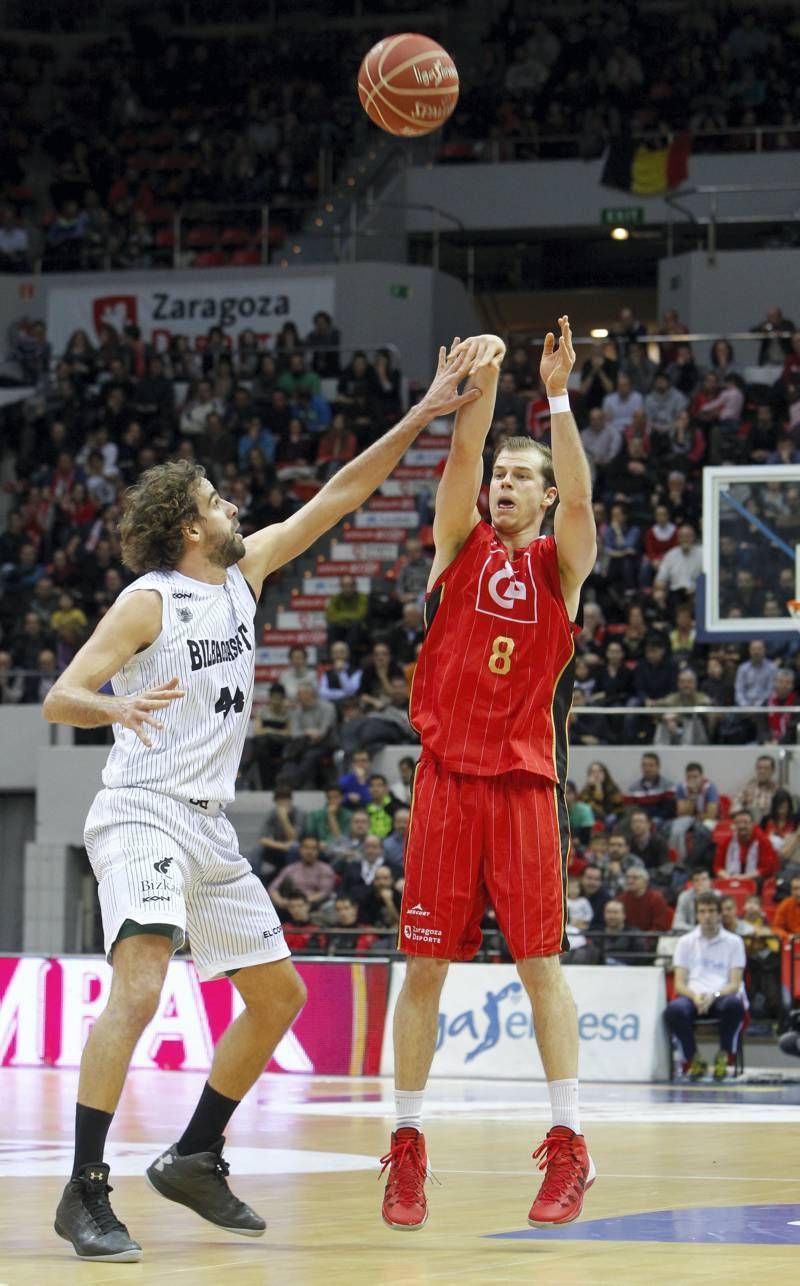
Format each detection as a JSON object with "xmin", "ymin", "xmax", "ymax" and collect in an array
[{"xmin": 103, "ymin": 565, "xmax": 256, "ymax": 802}]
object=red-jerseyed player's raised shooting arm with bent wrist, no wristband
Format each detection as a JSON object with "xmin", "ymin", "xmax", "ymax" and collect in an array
[{"xmin": 432, "ymin": 334, "xmax": 505, "ymax": 575}]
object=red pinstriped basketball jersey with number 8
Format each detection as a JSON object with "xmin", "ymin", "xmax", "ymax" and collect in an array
[{"xmin": 410, "ymin": 522, "xmax": 577, "ymax": 784}]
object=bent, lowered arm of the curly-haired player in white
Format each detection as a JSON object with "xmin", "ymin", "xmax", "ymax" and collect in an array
[{"xmin": 42, "ymin": 589, "xmax": 184, "ymax": 746}]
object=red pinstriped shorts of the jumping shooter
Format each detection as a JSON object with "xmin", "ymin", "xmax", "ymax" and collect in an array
[{"xmin": 397, "ymin": 752, "xmax": 570, "ymax": 961}]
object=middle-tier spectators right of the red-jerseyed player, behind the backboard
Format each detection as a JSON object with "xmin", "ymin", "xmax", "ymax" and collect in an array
[{"xmin": 540, "ymin": 309, "xmax": 800, "ymax": 746}]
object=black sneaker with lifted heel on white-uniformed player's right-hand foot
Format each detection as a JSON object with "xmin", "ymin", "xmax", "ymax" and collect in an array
[{"xmin": 144, "ymin": 1138, "xmax": 266, "ymax": 1237}]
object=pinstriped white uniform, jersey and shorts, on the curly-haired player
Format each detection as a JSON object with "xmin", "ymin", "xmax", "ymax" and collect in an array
[{"xmin": 84, "ymin": 566, "xmax": 289, "ymax": 979}]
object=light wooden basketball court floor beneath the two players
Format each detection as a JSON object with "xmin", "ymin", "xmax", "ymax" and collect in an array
[{"xmin": 0, "ymin": 1069, "xmax": 800, "ymax": 1286}]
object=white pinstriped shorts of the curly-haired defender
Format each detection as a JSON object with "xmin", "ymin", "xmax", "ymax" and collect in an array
[{"xmin": 84, "ymin": 786, "xmax": 291, "ymax": 981}]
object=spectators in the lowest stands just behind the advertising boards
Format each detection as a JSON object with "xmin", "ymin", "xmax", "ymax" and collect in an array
[{"xmin": 241, "ymin": 750, "xmax": 800, "ymax": 1033}]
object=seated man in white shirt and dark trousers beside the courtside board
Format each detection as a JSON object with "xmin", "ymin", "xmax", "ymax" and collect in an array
[{"xmin": 665, "ymin": 891, "xmax": 746, "ymax": 1080}]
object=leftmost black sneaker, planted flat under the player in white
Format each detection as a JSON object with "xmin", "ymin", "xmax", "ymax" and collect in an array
[{"xmin": 54, "ymin": 1161, "xmax": 141, "ymax": 1264}]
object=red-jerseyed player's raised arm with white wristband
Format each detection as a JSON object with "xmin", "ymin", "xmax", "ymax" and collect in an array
[{"xmin": 547, "ymin": 314, "xmax": 597, "ymax": 608}]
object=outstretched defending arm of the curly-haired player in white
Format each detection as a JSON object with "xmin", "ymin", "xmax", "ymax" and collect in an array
[{"xmin": 239, "ymin": 347, "xmax": 481, "ymax": 597}]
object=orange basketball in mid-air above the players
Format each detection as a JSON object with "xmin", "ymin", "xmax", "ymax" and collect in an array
[{"xmin": 359, "ymin": 32, "xmax": 458, "ymax": 138}]
